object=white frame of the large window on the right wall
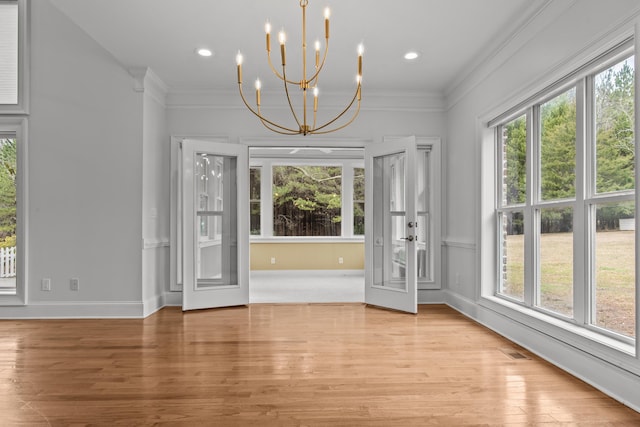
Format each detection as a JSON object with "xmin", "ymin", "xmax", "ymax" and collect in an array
[{"xmin": 476, "ymin": 33, "xmax": 640, "ymax": 374}]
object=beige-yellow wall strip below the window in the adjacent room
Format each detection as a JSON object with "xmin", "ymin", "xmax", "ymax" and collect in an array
[{"xmin": 251, "ymin": 242, "xmax": 364, "ymax": 270}]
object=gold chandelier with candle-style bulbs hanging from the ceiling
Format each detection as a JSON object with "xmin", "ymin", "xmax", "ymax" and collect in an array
[{"xmin": 236, "ymin": 0, "xmax": 364, "ymax": 135}]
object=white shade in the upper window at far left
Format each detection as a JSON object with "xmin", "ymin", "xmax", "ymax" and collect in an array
[{"xmin": 0, "ymin": 3, "xmax": 18, "ymax": 105}]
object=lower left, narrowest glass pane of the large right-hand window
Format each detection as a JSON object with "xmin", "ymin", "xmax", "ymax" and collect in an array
[{"xmin": 498, "ymin": 211, "xmax": 524, "ymax": 301}]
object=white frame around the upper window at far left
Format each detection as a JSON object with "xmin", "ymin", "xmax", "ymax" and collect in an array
[{"xmin": 0, "ymin": 0, "xmax": 30, "ymax": 114}]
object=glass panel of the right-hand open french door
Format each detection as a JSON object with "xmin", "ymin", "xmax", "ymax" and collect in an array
[{"xmin": 372, "ymin": 154, "xmax": 407, "ymax": 290}]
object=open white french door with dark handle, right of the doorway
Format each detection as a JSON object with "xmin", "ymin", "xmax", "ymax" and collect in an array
[{"xmin": 365, "ymin": 137, "xmax": 424, "ymax": 313}]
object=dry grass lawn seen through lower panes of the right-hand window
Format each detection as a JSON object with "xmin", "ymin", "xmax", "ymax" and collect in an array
[{"xmin": 503, "ymin": 231, "xmax": 635, "ymax": 337}]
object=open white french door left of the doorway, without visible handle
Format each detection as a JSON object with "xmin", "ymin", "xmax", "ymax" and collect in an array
[{"xmin": 181, "ymin": 140, "xmax": 249, "ymax": 310}]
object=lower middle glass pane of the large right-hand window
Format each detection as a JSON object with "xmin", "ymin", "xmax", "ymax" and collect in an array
[{"xmin": 537, "ymin": 208, "xmax": 573, "ymax": 317}]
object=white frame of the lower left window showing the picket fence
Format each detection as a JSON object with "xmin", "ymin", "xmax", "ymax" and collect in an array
[{"xmin": 0, "ymin": 117, "xmax": 29, "ymax": 306}]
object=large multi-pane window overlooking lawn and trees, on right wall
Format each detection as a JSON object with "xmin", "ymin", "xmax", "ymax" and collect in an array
[{"xmin": 495, "ymin": 47, "xmax": 636, "ymax": 343}]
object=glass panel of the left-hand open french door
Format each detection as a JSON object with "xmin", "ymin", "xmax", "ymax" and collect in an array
[{"xmin": 195, "ymin": 153, "xmax": 238, "ymax": 287}]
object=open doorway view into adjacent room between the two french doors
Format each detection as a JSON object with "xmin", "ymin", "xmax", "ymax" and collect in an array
[{"xmin": 249, "ymin": 146, "xmax": 364, "ymax": 303}]
